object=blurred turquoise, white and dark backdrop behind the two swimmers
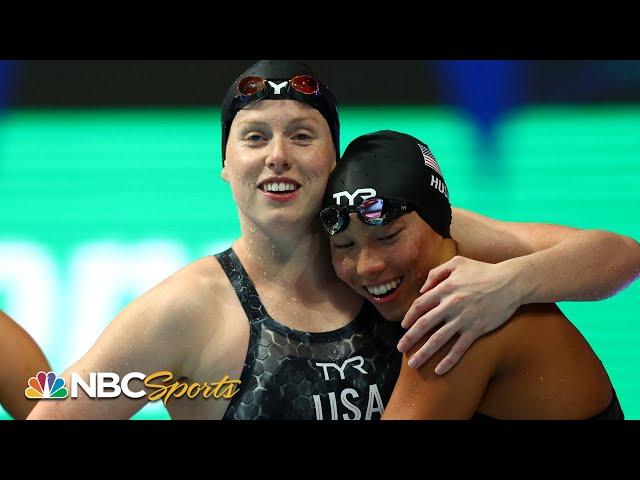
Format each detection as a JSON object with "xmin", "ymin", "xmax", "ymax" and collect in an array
[{"xmin": 0, "ymin": 60, "xmax": 640, "ymax": 419}]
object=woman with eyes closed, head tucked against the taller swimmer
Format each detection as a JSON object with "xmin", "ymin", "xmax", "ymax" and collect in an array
[{"xmin": 321, "ymin": 130, "xmax": 624, "ymax": 419}]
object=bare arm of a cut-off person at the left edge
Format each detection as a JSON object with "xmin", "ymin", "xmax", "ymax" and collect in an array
[{"xmin": 0, "ymin": 312, "xmax": 49, "ymax": 420}]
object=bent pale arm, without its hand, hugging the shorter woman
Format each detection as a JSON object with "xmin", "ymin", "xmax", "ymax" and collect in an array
[{"xmin": 451, "ymin": 208, "xmax": 640, "ymax": 305}]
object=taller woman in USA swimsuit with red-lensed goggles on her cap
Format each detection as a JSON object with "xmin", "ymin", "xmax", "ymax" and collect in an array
[{"xmin": 27, "ymin": 60, "xmax": 629, "ymax": 419}]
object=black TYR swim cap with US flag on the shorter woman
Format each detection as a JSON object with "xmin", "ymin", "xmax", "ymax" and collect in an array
[{"xmin": 324, "ymin": 130, "xmax": 451, "ymax": 238}]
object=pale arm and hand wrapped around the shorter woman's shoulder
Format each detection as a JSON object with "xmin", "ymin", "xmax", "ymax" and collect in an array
[{"xmin": 398, "ymin": 208, "xmax": 640, "ymax": 374}]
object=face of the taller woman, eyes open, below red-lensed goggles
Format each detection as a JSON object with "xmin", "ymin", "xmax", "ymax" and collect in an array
[{"xmin": 222, "ymin": 100, "xmax": 335, "ymax": 231}]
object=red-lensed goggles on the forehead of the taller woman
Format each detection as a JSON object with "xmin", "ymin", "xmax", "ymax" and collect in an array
[{"xmin": 234, "ymin": 75, "xmax": 321, "ymax": 109}]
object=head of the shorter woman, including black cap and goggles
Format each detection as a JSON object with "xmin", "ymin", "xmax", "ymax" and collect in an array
[{"xmin": 320, "ymin": 131, "xmax": 456, "ymax": 321}]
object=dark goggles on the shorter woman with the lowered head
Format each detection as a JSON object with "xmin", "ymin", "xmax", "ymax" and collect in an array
[{"xmin": 320, "ymin": 197, "xmax": 415, "ymax": 235}]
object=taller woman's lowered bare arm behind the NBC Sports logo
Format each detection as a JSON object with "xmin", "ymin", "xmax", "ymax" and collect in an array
[{"xmin": 28, "ymin": 274, "xmax": 205, "ymax": 420}]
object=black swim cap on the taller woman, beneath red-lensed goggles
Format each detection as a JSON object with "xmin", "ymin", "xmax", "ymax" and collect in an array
[{"xmin": 222, "ymin": 60, "xmax": 340, "ymax": 165}]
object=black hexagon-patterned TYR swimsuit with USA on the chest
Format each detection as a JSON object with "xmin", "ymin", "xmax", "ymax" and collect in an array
[{"xmin": 216, "ymin": 249, "xmax": 402, "ymax": 420}]
